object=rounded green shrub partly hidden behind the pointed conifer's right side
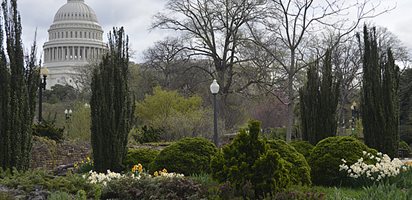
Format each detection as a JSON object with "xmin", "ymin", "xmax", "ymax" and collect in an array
[{"xmin": 267, "ymin": 139, "xmax": 311, "ymax": 185}]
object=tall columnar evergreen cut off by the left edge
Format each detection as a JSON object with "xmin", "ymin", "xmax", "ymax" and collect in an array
[{"xmin": 0, "ymin": 0, "xmax": 39, "ymax": 170}]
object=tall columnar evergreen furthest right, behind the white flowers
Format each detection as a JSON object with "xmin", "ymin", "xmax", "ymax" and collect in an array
[{"xmin": 361, "ymin": 26, "xmax": 399, "ymax": 157}]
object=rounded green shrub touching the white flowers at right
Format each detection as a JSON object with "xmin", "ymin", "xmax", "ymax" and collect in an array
[{"xmin": 309, "ymin": 136, "xmax": 377, "ymax": 186}]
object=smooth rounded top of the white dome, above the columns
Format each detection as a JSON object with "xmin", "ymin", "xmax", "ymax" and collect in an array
[{"xmin": 53, "ymin": 0, "xmax": 98, "ymax": 23}]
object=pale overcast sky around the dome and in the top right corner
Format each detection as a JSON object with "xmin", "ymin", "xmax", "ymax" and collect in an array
[{"xmin": 18, "ymin": 0, "xmax": 412, "ymax": 61}]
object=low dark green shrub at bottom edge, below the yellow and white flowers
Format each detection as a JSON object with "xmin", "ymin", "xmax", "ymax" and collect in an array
[{"xmin": 102, "ymin": 177, "xmax": 206, "ymax": 200}]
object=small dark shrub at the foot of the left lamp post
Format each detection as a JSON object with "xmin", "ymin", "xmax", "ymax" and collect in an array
[{"xmin": 33, "ymin": 120, "xmax": 64, "ymax": 142}]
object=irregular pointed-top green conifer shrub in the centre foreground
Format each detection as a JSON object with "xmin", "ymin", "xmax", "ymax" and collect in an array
[{"xmin": 211, "ymin": 121, "xmax": 290, "ymax": 198}]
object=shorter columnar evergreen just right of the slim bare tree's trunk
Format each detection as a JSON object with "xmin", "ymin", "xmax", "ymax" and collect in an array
[{"xmin": 299, "ymin": 51, "xmax": 340, "ymax": 145}]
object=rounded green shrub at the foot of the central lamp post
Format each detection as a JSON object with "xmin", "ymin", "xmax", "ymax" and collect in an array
[{"xmin": 150, "ymin": 137, "xmax": 217, "ymax": 175}]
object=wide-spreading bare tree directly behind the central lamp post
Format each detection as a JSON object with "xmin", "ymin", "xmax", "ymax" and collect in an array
[{"xmin": 153, "ymin": 0, "xmax": 263, "ymax": 129}]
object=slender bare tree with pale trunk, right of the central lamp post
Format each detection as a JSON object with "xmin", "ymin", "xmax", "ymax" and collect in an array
[{"xmin": 249, "ymin": 0, "xmax": 387, "ymax": 141}]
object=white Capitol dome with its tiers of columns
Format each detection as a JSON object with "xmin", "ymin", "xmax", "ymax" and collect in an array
[{"xmin": 43, "ymin": 0, "xmax": 107, "ymax": 89}]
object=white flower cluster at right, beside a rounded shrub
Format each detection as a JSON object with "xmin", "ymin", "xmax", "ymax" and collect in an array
[{"xmin": 339, "ymin": 151, "xmax": 406, "ymax": 181}]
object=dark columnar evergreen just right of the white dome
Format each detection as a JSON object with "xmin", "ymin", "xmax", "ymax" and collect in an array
[{"xmin": 90, "ymin": 28, "xmax": 133, "ymax": 172}]
